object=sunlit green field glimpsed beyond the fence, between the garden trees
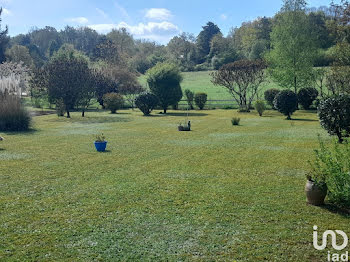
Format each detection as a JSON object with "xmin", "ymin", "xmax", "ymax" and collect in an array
[{"xmin": 139, "ymin": 71, "xmax": 278, "ymax": 100}]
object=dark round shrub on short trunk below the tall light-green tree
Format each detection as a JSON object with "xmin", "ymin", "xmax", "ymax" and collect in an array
[{"xmin": 273, "ymin": 90, "xmax": 298, "ymax": 120}]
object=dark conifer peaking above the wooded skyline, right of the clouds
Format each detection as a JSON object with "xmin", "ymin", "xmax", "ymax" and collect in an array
[{"xmin": 196, "ymin": 22, "xmax": 221, "ymax": 62}]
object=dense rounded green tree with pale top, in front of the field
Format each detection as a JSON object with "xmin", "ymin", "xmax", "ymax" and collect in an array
[{"xmin": 146, "ymin": 63, "xmax": 182, "ymax": 114}]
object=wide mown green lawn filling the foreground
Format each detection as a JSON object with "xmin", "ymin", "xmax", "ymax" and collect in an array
[{"xmin": 0, "ymin": 108, "xmax": 350, "ymax": 261}]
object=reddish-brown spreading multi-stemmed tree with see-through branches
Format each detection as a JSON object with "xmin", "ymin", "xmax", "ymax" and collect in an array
[{"xmin": 211, "ymin": 60, "xmax": 266, "ymax": 112}]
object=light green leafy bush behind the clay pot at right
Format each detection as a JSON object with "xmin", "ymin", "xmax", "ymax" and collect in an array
[{"xmin": 312, "ymin": 138, "xmax": 350, "ymax": 207}]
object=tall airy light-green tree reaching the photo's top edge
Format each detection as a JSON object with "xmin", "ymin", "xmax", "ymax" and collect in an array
[{"xmin": 266, "ymin": 0, "xmax": 317, "ymax": 93}]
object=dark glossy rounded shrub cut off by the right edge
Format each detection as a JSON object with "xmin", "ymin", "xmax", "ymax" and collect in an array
[{"xmin": 318, "ymin": 95, "xmax": 350, "ymax": 143}]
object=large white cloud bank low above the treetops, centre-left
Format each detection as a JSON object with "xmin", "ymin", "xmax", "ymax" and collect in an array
[{"xmin": 89, "ymin": 21, "xmax": 181, "ymax": 43}]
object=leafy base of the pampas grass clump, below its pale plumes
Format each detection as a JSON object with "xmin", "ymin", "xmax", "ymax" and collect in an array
[{"xmin": 0, "ymin": 93, "xmax": 31, "ymax": 131}]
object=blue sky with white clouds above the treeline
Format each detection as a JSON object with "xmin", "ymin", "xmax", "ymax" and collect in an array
[{"xmin": 0, "ymin": 0, "xmax": 340, "ymax": 44}]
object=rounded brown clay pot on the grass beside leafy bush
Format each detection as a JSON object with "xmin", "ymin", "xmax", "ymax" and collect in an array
[{"xmin": 305, "ymin": 174, "xmax": 328, "ymax": 206}]
